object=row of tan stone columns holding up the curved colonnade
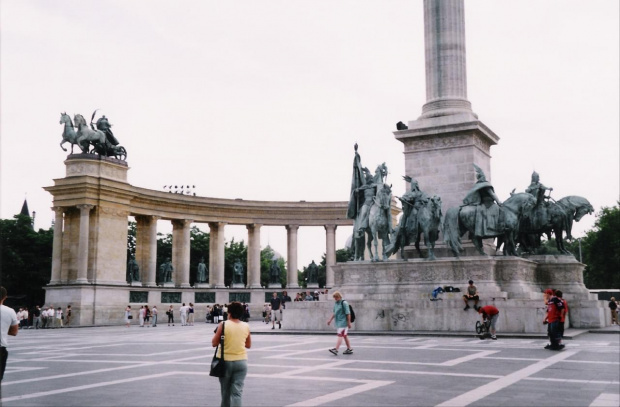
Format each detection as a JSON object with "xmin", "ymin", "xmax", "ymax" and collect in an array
[{"xmin": 50, "ymin": 204, "xmax": 337, "ymax": 288}]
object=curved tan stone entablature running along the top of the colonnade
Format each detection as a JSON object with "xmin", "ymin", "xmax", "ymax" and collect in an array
[{"xmin": 44, "ymin": 175, "xmax": 353, "ymax": 226}]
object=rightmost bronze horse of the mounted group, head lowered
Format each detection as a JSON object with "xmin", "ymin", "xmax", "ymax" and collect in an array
[{"xmin": 512, "ymin": 196, "xmax": 594, "ymax": 254}]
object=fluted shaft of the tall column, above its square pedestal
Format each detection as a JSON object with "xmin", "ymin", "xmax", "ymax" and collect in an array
[{"xmin": 421, "ymin": 0, "xmax": 472, "ymax": 118}]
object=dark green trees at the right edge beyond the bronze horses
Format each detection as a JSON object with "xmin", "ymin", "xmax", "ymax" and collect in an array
[{"xmin": 581, "ymin": 201, "xmax": 620, "ymax": 289}]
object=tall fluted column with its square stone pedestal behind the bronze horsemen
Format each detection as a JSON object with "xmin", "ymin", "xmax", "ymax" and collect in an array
[{"xmin": 394, "ymin": 0, "xmax": 499, "ymax": 220}]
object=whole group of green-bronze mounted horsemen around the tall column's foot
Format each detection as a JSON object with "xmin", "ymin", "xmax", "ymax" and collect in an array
[{"xmin": 347, "ymin": 144, "xmax": 594, "ymax": 261}]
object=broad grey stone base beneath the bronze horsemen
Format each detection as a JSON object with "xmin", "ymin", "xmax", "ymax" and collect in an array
[{"xmin": 287, "ymin": 256, "xmax": 607, "ymax": 333}]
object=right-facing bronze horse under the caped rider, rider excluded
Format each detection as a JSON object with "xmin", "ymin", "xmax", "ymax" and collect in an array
[{"xmin": 443, "ymin": 192, "xmax": 536, "ymax": 257}]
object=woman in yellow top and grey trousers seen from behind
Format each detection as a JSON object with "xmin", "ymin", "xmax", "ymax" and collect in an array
[{"xmin": 211, "ymin": 301, "xmax": 252, "ymax": 407}]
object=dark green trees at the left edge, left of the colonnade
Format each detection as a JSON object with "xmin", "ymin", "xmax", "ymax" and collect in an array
[{"xmin": 0, "ymin": 215, "xmax": 54, "ymax": 308}]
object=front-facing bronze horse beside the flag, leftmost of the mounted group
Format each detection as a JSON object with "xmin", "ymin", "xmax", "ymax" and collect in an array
[{"xmin": 367, "ymin": 184, "xmax": 392, "ymax": 261}]
